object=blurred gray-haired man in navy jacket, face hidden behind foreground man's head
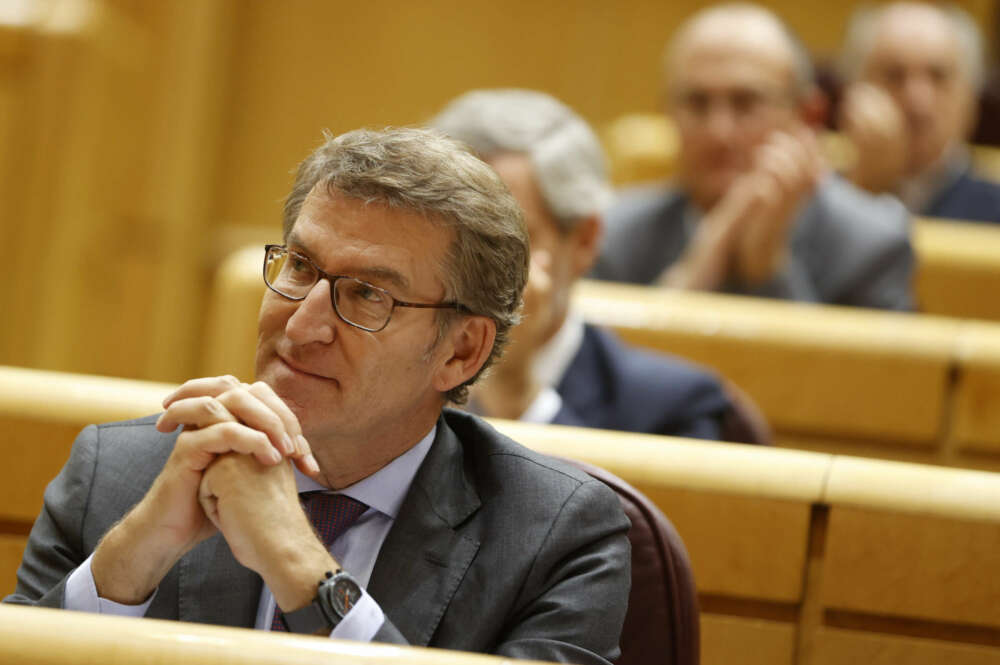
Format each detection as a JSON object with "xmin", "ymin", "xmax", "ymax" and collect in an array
[{"xmin": 432, "ymin": 90, "xmax": 760, "ymax": 439}]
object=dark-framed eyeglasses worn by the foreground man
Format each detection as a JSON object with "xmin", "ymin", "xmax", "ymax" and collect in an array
[{"xmin": 264, "ymin": 245, "xmax": 468, "ymax": 332}]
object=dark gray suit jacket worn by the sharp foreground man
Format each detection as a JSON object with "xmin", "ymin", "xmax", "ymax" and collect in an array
[{"xmin": 5, "ymin": 409, "xmax": 630, "ymax": 663}]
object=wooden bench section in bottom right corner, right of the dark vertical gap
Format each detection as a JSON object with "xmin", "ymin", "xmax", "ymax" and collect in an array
[{"xmin": 809, "ymin": 457, "xmax": 1000, "ymax": 665}]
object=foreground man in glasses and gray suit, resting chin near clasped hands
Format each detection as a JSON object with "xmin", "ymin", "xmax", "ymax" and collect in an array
[{"xmin": 7, "ymin": 130, "xmax": 629, "ymax": 663}]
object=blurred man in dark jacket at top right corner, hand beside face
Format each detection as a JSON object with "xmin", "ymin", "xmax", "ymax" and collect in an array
[{"xmin": 841, "ymin": 2, "xmax": 1000, "ymax": 222}]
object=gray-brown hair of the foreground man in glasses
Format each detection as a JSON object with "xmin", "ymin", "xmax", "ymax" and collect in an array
[{"xmin": 284, "ymin": 129, "xmax": 529, "ymax": 404}]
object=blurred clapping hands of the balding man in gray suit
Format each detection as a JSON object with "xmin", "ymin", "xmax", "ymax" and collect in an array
[{"xmin": 660, "ymin": 126, "xmax": 826, "ymax": 290}]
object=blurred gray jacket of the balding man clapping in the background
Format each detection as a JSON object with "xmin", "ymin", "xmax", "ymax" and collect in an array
[{"xmin": 593, "ymin": 176, "xmax": 914, "ymax": 309}]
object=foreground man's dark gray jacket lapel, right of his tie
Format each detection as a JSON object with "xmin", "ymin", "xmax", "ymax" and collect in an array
[{"xmin": 368, "ymin": 417, "xmax": 480, "ymax": 646}]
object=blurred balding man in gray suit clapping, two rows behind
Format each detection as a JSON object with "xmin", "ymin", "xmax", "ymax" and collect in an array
[{"xmin": 594, "ymin": 4, "xmax": 913, "ymax": 309}]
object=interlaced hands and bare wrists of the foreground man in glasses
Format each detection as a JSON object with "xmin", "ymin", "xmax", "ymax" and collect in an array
[{"xmin": 91, "ymin": 377, "xmax": 332, "ymax": 608}]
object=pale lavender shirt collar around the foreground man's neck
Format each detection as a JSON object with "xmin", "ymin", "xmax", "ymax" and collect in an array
[{"xmin": 293, "ymin": 425, "xmax": 437, "ymax": 519}]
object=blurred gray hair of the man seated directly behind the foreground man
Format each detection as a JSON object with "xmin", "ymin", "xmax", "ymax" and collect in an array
[{"xmin": 430, "ymin": 89, "xmax": 613, "ymax": 231}]
